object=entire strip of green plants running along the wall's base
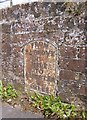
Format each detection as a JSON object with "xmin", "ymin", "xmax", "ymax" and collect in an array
[{"xmin": 0, "ymin": 81, "xmax": 87, "ymax": 120}]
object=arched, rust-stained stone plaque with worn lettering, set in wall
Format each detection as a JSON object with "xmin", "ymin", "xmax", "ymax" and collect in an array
[{"xmin": 24, "ymin": 41, "xmax": 57, "ymax": 94}]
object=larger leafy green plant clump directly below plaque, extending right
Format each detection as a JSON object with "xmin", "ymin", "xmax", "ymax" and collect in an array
[{"xmin": 31, "ymin": 93, "xmax": 87, "ymax": 119}]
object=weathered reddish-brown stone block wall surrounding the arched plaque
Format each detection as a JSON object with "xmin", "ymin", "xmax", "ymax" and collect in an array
[{"xmin": 0, "ymin": 2, "xmax": 87, "ymax": 109}]
